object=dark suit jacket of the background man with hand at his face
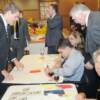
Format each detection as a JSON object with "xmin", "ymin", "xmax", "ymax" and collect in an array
[{"xmin": 45, "ymin": 15, "xmax": 63, "ymax": 46}]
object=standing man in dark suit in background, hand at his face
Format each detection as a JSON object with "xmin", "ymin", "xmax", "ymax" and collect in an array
[{"xmin": 45, "ymin": 4, "xmax": 63, "ymax": 54}]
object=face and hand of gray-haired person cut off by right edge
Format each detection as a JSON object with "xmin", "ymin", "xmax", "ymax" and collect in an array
[{"xmin": 77, "ymin": 48, "xmax": 100, "ymax": 100}]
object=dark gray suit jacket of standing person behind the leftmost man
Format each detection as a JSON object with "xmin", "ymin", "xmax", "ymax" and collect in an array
[{"xmin": 11, "ymin": 18, "xmax": 30, "ymax": 48}]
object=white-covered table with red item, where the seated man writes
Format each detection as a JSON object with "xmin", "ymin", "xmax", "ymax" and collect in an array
[{"xmin": 3, "ymin": 54, "xmax": 62, "ymax": 84}]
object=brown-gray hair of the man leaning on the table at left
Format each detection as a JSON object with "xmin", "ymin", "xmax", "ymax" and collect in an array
[{"xmin": 3, "ymin": 3, "xmax": 20, "ymax": 14}]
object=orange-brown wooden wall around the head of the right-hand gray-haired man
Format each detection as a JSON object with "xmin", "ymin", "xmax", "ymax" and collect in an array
[{"xmin": 59, "ymin": 0, "xmax": 98, "ymax": 28}]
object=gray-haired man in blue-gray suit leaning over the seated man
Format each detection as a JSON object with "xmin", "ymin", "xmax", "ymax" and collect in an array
[{"xmin": 70, "ymin": 4, "xmax": 100, "ymax": 55}]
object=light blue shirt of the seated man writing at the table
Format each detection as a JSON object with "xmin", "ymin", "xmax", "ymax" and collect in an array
[{"xmin": 54, "ymin": 49, "xmax": 84, "ymax": 81}]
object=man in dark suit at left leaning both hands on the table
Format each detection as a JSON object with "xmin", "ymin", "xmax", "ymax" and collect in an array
[{"xmin": 0, "ymin": 3, "xmax": 22, "ymax": 82}]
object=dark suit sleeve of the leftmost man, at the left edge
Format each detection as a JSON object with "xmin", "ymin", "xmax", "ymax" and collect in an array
[{"xmin": 0, "ymin": 20, "xmax": 8, "ymax": 71}]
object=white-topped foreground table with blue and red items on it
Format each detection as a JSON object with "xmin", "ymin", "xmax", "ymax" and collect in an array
[{"xmin": 1, "ymin": 84, "xmax": 77, "ymax": 100}]
